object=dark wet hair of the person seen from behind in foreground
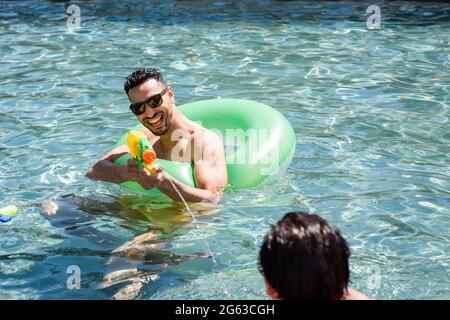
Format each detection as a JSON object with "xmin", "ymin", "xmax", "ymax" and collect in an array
[{"xmin": 259, "ymin": 212, "xmax": 350, "ymax": 300}]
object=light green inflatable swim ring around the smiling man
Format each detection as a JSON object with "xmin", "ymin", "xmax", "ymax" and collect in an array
[{"xmin": 114, "ymin": 99, "xmax": 296, "ymax": 195}]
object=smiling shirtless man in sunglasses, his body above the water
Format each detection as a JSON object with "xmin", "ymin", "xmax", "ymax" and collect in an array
[{"xmin": 86, "ymin": 69, "xmax": 228, "ymax": 202}]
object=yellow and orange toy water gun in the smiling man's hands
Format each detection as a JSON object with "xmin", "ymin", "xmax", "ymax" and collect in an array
[{"xmin": 127, "ymin": 131, "xmax": 158, "ymax": 173}]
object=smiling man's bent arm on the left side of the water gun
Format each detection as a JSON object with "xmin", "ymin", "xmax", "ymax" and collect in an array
[{"xmin": 86, "ymin": 144, "xmax": 130, "ymax": 183}]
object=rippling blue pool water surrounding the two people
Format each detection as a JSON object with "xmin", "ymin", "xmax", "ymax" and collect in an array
[{"xmin": 0, "ymin": 1, "xmax": 450, "ymax": 299}]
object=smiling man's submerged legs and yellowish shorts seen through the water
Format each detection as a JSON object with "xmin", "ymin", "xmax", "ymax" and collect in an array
[{"xmin": 41, "ymin": 195, "xmax": 218, "ymax": 299}]
